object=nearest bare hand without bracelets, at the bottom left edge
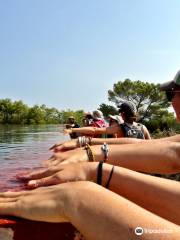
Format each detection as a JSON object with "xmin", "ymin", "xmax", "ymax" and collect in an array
[{"xmin": 0, "ymin": 183, "xmax": 73, "ymax": 222}]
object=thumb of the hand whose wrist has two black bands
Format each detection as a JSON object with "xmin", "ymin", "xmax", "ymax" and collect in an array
[{"xmin": 27, "ymin": 176, "xmax": 61, "ymax": 188}]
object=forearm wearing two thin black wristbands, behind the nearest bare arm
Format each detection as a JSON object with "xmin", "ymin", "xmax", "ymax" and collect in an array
[{"xmin": 99, "ymin": 164, "xmax": 180, "ymax": 225}]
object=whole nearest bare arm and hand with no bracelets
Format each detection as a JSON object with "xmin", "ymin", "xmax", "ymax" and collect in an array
[{"xmin": 0, "ymin": 182, "xmax": 180, "ymax": 240}]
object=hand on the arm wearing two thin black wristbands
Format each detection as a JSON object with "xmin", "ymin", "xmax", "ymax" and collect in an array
[{"xmin": 17, "ymin": 162, "xmax": 98, "ymax": 188}]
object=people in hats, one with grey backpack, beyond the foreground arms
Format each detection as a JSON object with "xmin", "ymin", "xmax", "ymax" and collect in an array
[{"xmin": 65, "ymin": 101, "xmax": 151, "ymax": 139}]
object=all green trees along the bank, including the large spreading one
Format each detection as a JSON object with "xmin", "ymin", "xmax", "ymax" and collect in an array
[{"xmin": 0, "ymin": 79, "xmax": 180, "ymax": 134}]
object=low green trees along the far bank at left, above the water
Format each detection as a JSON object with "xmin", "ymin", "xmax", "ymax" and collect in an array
[{"xmin": 0, "ymin": 98, "xmax": 84, "ymax": 124}]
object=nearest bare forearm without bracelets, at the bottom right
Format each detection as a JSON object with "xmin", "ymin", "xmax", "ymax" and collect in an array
[{"xmin": 66, "ymin": 182, "xmax": 180, "ymax": 240}]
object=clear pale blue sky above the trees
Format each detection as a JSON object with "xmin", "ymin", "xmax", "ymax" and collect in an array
[{"xmin": 0, "ymin": 0, "xmax": 180, "ymax": 111}]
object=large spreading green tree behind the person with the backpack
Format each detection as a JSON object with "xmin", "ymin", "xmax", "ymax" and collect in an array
[{"xmin": 100, "ymin": 79, "xmax": 176, "ymax": 132}]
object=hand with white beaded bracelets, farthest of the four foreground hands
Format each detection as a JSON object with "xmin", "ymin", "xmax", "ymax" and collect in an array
[{"xmin": 49, "ymin": 139, "xmax": 79, "ymax": 152}]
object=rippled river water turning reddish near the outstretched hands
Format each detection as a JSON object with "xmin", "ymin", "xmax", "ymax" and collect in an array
[{"xmin": 0, "ymin": 125, "xmax": 69, "ymax": 191}]
